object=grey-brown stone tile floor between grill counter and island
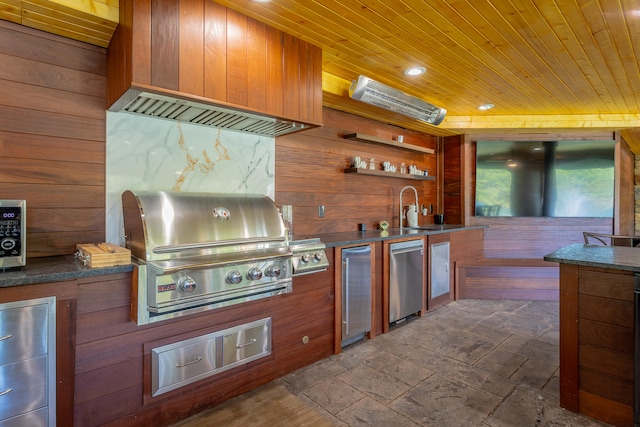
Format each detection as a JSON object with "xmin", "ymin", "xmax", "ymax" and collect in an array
[{"xmin": 276, "ymin": 300, "xmax": 606, "ymax": 427}]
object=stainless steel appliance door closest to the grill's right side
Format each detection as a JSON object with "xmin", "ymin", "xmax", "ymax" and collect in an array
[{"xmin": 341, "ymin": 246, "xmax": 371, "ymax": 347}]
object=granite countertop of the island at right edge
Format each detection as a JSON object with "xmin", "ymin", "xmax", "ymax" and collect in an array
[{"xmin": 544, "ymin": 243, "xmax": 640, "ymax": 272}]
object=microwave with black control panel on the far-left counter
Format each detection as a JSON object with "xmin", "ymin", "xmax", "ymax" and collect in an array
[{"xmin": 0, "ymin": 200, "xmax": 27, "ymax": 270}]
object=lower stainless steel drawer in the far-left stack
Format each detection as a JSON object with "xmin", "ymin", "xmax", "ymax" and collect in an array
[{"xmin": 0, "ymin": 356, "xmax": 47, "ymax": 420}]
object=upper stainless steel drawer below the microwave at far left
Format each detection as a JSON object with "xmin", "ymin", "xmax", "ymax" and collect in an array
[{"xmin": 0, "ymin": 303, "xmax": 49, "ymax": 364}]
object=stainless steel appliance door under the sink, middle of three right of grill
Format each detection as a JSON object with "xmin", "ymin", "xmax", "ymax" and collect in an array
[{"xmin": 389, "ymin": 240, "xmax": 424, "ymax": 323}]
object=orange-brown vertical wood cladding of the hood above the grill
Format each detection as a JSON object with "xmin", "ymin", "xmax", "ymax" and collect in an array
[{"xmin": 108, "ymin": 0, "xmax": 322, "ymax": 125}]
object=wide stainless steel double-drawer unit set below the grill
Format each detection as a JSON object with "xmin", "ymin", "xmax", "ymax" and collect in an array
[{"xmin": 151, "ymin": 317, "xmax": 271, "ymax": 396}]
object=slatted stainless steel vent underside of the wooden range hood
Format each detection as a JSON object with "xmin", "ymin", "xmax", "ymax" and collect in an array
[{"xmin": 111, "ymin": 90, "xmax": 309, "ymax": 138}]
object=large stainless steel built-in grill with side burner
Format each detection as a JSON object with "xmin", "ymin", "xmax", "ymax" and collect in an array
[{"xmin": 122, "ymin": 191, "xmax": 328, "ymax": 324}]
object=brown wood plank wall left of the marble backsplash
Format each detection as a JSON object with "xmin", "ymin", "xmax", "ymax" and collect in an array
[{"xmin": 0, "ymin": 21, "xmax": 106, "ymax": 258}]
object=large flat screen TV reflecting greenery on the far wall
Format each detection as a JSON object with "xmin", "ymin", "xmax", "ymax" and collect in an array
[{"xmin": 475, "ymin": 141, "xmax": 615, "ymax": 217}]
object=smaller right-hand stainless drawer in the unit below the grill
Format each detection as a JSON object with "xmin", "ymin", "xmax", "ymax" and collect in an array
[{"xmin": 222, "ymin": 318, "xmax": 271, "ymax": 368}]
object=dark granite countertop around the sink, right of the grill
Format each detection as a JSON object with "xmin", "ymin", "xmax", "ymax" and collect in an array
[{"xmin": 308, "ymin": 224, "xmax": 485, "ymax": 248}]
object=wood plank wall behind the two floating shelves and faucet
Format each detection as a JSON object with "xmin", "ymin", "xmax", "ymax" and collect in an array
[{"xmin": 275, "ymin": 108, "xmax": 437, "ymax": 236}]
